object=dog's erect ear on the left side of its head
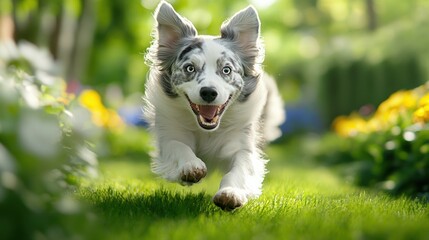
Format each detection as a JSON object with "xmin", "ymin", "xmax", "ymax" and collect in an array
[{"xmin": 155, "ymin": 1, "xmax": 197, "ymax": 48}]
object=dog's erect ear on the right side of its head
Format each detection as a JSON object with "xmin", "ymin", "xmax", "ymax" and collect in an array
[{"xmin": 220, "ymin": 6, "xmax": 260, "ymax": 49}]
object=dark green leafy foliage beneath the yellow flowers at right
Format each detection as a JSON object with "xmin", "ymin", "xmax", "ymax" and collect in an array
[{"xmin": 318, "ymin": 125, "xmax": 429, "ymax": 198}]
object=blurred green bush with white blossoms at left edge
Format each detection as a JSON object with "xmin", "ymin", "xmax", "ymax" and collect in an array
[{"xmin": 0, "ymin": 44, "xmax": 97, "ymax": 239}]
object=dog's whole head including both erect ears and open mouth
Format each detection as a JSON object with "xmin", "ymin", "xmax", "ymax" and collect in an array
[{"xmin": 148, "ymin": 2, "xmax": 263, "ymax": 131}]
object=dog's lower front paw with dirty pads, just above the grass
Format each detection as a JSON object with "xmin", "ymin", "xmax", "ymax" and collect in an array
[{"xmin": 213, "ymin": 187, "xmax": 247, "ymax": 211}]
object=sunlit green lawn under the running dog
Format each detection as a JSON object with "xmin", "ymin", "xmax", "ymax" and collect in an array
[{"xmin": 79, "ymin": 140, "xmax": 429, "ymax": 240}]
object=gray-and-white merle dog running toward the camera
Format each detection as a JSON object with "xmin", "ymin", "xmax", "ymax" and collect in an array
[{"xmin": 143, "ymin": 1, "xmax": 285, "ymax": 211}]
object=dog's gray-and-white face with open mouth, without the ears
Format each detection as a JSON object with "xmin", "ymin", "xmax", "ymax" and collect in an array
[{"xmin": 171, "ymin": 39, "xmax": 244, "ymax": 130}]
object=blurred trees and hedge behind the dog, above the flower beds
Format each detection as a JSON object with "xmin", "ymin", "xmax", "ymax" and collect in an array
[{"xmin": 0, "ymin": 0, "xmax": 429, "ymax": 132}]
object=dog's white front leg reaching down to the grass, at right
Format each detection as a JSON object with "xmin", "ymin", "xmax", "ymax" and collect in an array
[{"xmin": 213, "ymin": 150, "xmax": 266, "ymax": 211}]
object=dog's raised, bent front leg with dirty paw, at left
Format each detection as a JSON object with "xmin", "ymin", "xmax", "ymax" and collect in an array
[{"xmin": 152, "ymin": 140, "xmax": 207, "ymax": 185}]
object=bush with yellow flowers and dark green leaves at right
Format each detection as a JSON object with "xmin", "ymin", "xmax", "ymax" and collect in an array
[{"xmin": 323, "ymin": 85, "xmax": 429, "ymax": 196}]
